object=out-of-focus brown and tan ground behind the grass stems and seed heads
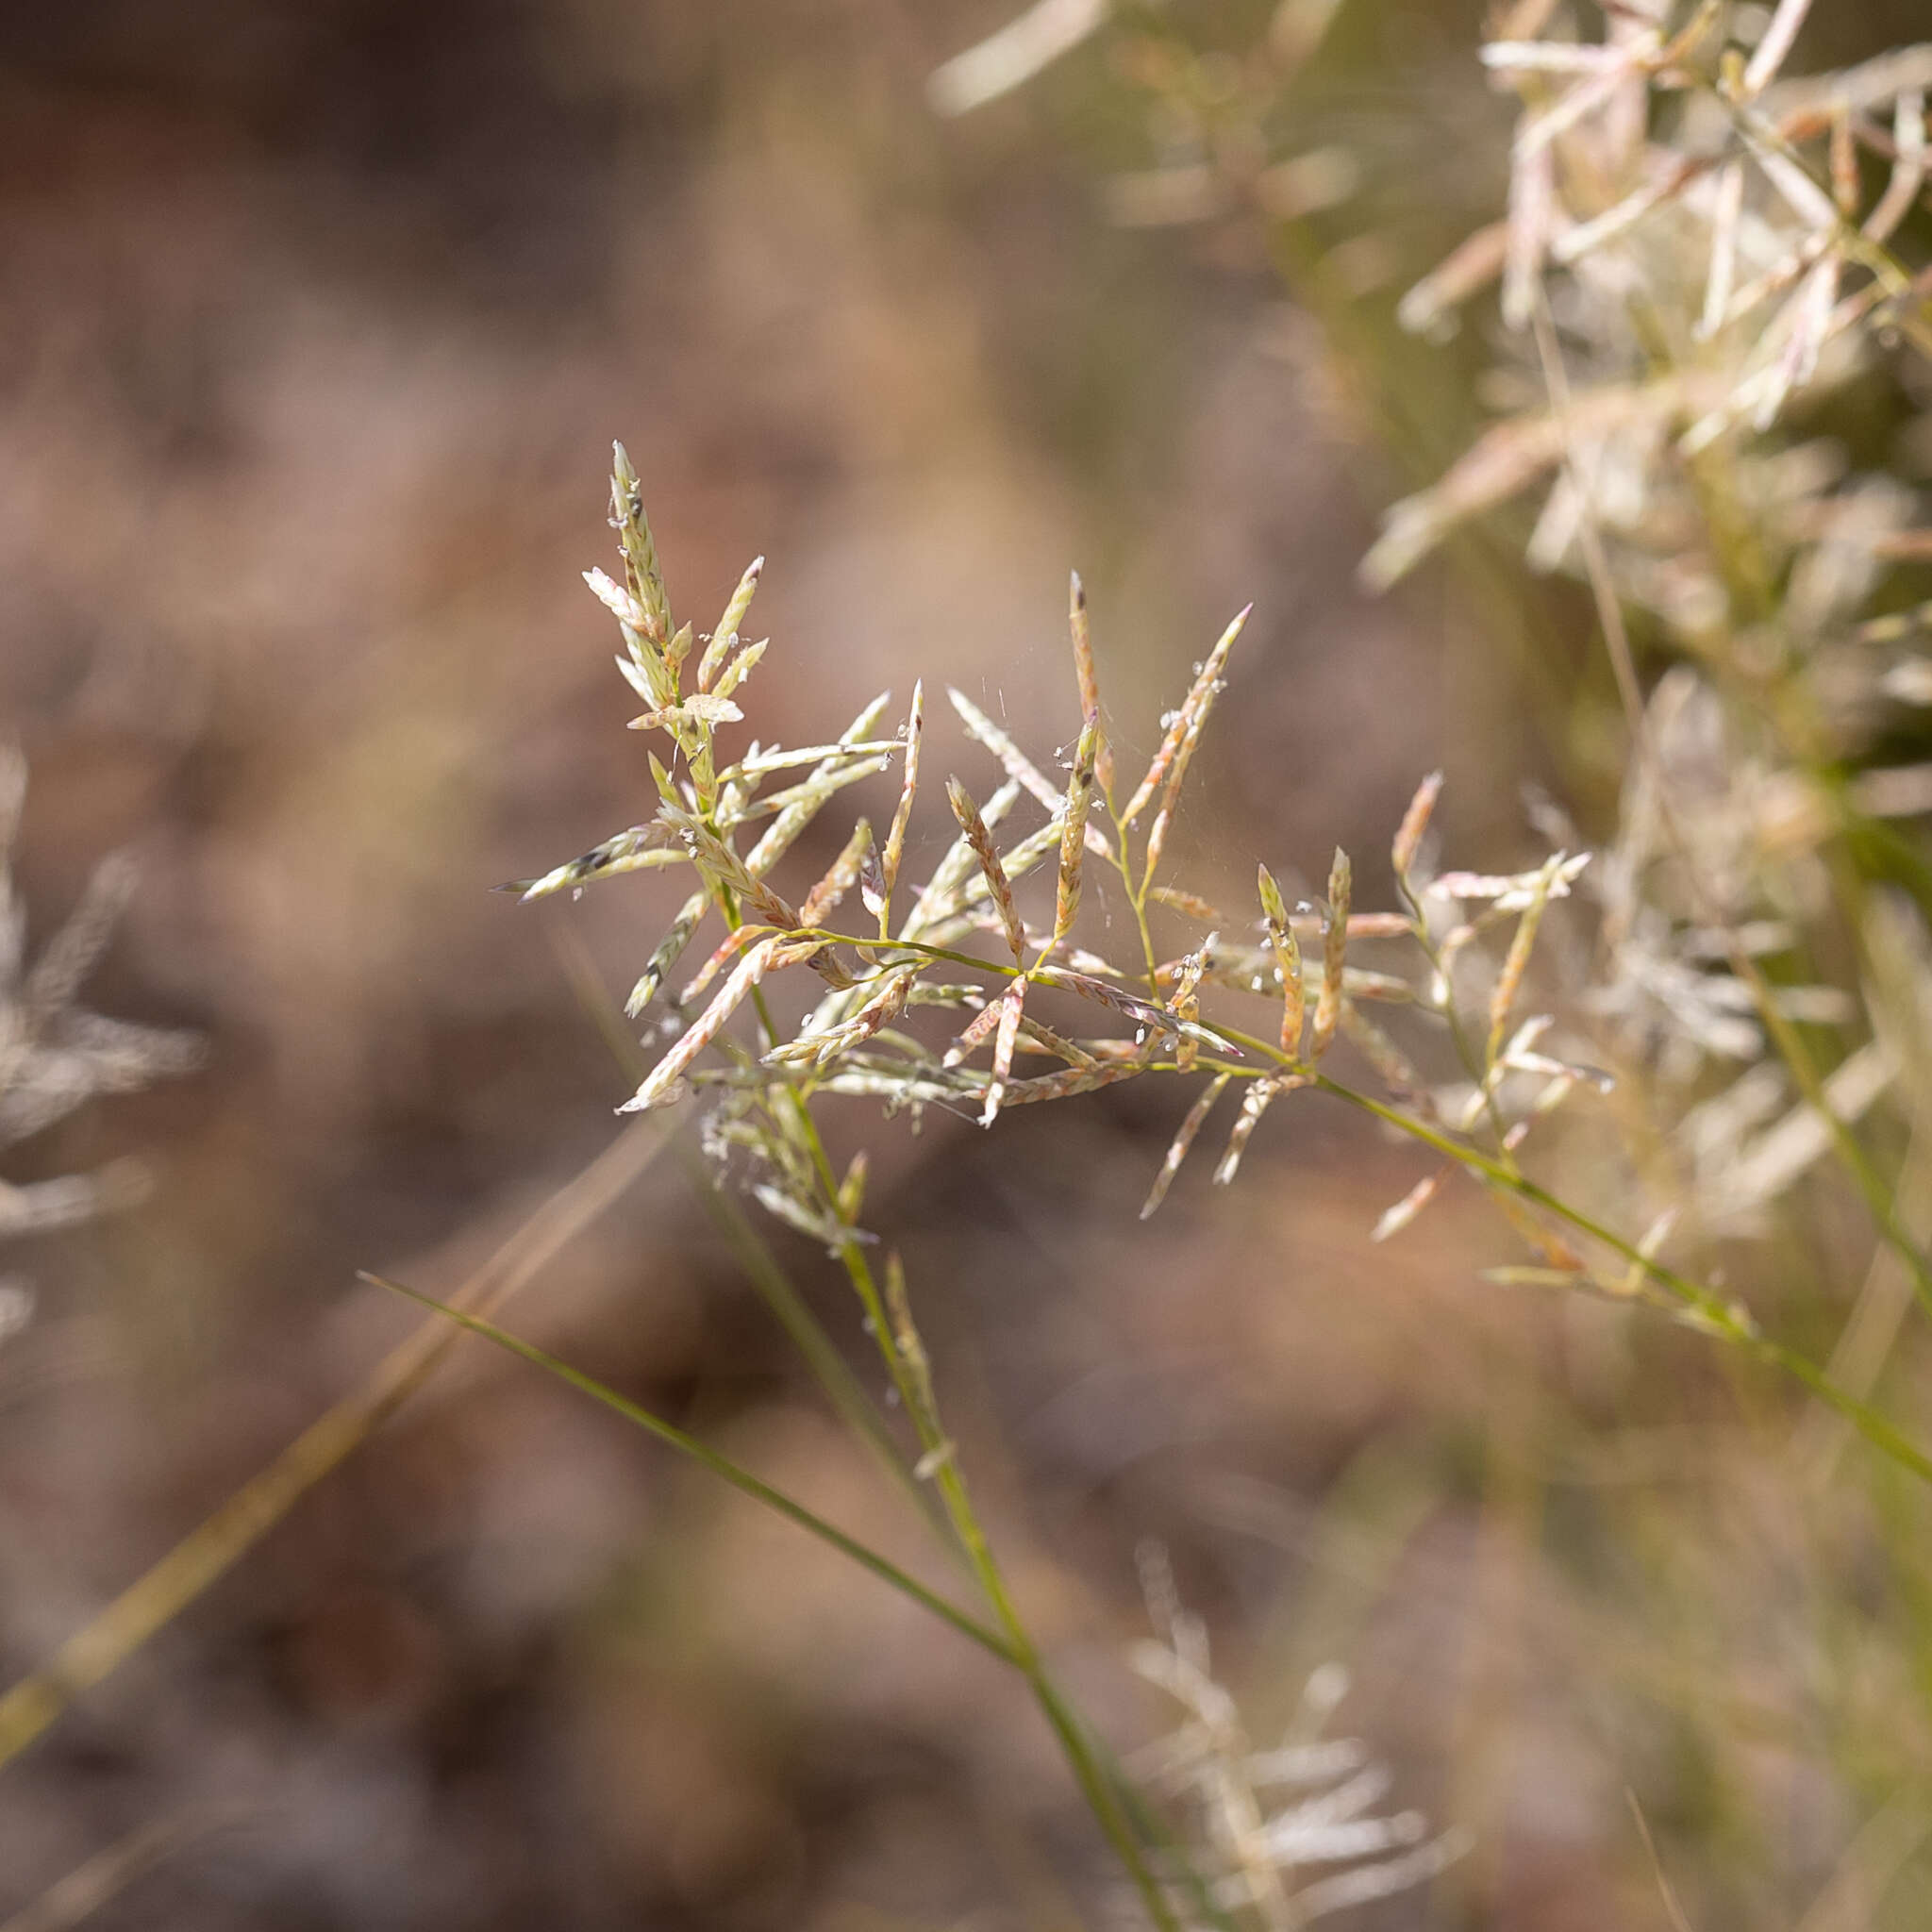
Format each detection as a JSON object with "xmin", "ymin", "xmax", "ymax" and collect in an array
[{"xmin": 0, "ymin": 0, "xmax": 1932, "ymax": 1932}]
